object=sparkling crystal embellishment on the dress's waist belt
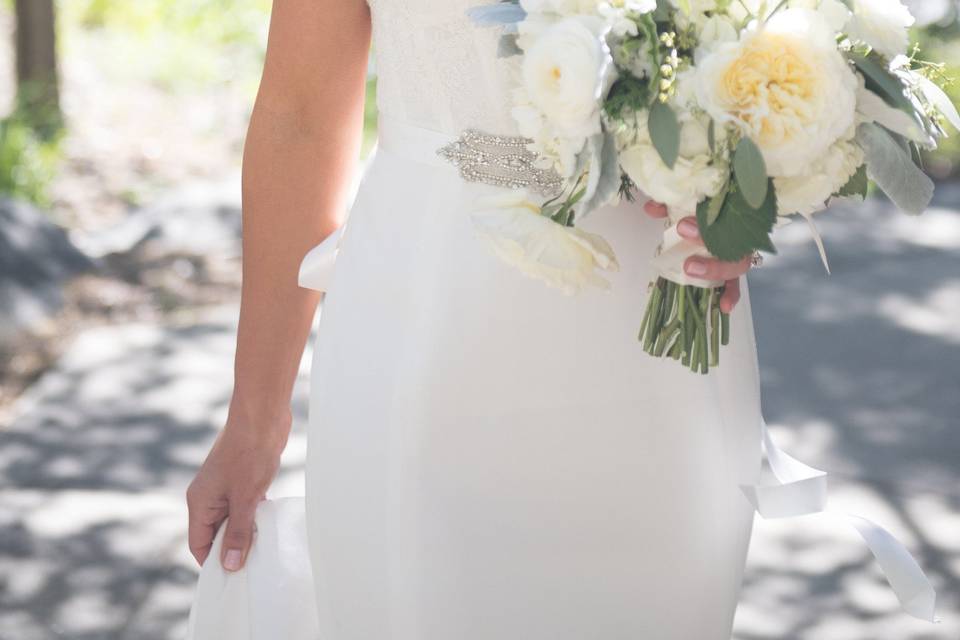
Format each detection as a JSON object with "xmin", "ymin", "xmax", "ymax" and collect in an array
[{"xmin": 437, "ymin": 129, "xmax": 563, "ymax": 196}]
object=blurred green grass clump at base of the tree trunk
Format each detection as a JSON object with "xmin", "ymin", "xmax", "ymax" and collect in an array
[{"xmin": 0, "ymin": 114, "xmax": 61, "ymax": 207}]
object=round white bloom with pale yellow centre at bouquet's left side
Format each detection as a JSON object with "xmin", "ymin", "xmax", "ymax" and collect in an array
[{"xmin": 521, "ymin": 16, "xmax": 616, "ymax": 138}]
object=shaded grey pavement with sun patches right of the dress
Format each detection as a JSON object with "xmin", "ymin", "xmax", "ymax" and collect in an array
[{"xmin": 736, "ymin": 189, "xmax": 960, "ymax": 640}]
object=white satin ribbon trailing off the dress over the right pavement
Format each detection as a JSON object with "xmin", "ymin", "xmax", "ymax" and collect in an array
[{"xmin": 740, "ymin": 423, "xmax": 939, "ymax": 622}]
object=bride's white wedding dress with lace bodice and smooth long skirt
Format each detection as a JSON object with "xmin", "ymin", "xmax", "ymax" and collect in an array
[{"xmin": 184, "ymin": 0, "xmax": 932, "ymax": 640}]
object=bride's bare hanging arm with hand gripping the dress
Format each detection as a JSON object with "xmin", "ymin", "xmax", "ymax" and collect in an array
[{"xmin": 187, "ymin": 0, "xmax": 370, "ymax": 570}]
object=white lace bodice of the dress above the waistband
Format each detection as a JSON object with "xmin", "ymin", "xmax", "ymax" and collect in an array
[{"xmin": 368, "ymin": 0, "xmax": 516, "ymax": 135}]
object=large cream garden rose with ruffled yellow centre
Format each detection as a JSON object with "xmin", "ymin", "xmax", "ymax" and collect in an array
[{"xmin": 697, "ymin": 9, "xmax": 857, "ymax": 177}]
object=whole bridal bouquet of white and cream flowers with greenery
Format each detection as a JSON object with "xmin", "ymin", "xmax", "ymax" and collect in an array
[{"xmin": 470, "ymin": 0, "xmax": 960, "ymax": 373}]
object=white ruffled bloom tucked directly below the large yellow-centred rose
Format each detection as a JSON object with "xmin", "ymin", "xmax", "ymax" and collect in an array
[{"xmin": 773, "ymin": 140, "xmax": 864, "ymax": 216}]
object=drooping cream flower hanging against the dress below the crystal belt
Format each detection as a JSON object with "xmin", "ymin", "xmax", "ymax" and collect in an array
[{"xmin": 471, "ymin": 190, "xmax": 620, "ymax": 295}]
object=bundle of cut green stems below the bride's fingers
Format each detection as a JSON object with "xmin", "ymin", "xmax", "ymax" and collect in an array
[{"xmin": 640, "ymin": 278, "xmax": 730, "ymax": 374}]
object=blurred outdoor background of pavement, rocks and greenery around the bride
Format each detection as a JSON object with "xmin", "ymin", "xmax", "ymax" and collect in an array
[{"xmin": 0, "ymin": 0, "xmax": 960, "ymax": 640}]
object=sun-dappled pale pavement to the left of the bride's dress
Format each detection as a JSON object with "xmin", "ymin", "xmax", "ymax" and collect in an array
[{"xmin": 0, "ymin": 307, "xmax": 306, "ymax": 640}]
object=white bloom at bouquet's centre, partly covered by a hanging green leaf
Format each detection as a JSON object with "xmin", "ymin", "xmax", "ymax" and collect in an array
[{"xmin": 620, "ymin": 107, "xmax": 729, "ymax": 215}]
